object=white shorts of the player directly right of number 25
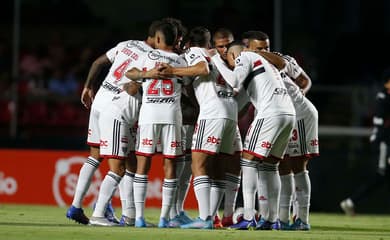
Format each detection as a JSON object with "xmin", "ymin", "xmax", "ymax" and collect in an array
[{"xmin": 191, "ymin": 119, "xmax": 237, "ymax": 155}]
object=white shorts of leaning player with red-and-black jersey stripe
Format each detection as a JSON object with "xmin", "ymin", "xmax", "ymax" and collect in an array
[{"xmin": 244, "ymin": 115, "xmax": 295, "ymax": 159}]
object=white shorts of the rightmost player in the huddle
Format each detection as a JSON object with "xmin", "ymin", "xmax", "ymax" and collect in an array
[{"xmin": 286, "ymin": 109, "xmax": 319, "ymax": 157}]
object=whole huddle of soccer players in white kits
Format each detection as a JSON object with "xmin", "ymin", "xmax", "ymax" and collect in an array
[{"xmin": 66, "ymin": 18, "xmax": 319, "ymax": 230}]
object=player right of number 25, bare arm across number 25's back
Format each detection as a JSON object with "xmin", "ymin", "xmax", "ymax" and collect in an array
[{"xmin": 158, "ymin": 27, "xmax": 237, "ymax": 229}]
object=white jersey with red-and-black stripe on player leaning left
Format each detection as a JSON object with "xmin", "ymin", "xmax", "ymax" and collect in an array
[{"xmin": 213, "ymin": 52, "xmax": 295, "ymax": 118}]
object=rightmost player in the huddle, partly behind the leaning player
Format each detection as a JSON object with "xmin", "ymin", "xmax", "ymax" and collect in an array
[{"xmin": 247, "ymin": 31, "xmax": 319, "ymax": 230}]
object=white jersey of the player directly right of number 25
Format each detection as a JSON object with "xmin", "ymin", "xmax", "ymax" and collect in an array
[{"xmin": 185, "ymin": 47, "xmax": 237, "ymax": 121}]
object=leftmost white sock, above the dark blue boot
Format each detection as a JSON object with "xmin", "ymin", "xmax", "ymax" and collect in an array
[{"xmin": 72, "ymin": 156, "xmax": 100, "ymax": 208}]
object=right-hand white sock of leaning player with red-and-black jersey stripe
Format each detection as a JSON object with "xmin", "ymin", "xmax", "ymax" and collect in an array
[{"xmin": 263, "ymin": 162, "xmax": 281, "ymax": 222}]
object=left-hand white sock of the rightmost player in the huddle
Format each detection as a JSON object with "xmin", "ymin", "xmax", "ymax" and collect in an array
[{"xmin": 279, "ymin": 174, "xmax": 294, "ymax": 223}]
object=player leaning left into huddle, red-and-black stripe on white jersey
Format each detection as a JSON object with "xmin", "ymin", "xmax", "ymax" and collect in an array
[{"xmin": 212, "ymin": 43, "xmax": 295, "ymax": 229}]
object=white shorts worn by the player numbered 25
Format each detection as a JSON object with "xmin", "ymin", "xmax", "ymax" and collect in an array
[{"xmin": 136, "ymin": 124, "xmax": 183, "ymax": 158}]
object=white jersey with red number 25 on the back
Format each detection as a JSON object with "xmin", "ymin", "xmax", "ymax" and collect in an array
[{"xmin": 138, "ymin": 50, "xmax": 187, "ymax": 125}]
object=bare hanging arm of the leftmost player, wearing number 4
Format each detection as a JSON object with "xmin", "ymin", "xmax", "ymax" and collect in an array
[{"xmin": 81, "ymin": 54, "xmax": 111, "ymax": 109}]
